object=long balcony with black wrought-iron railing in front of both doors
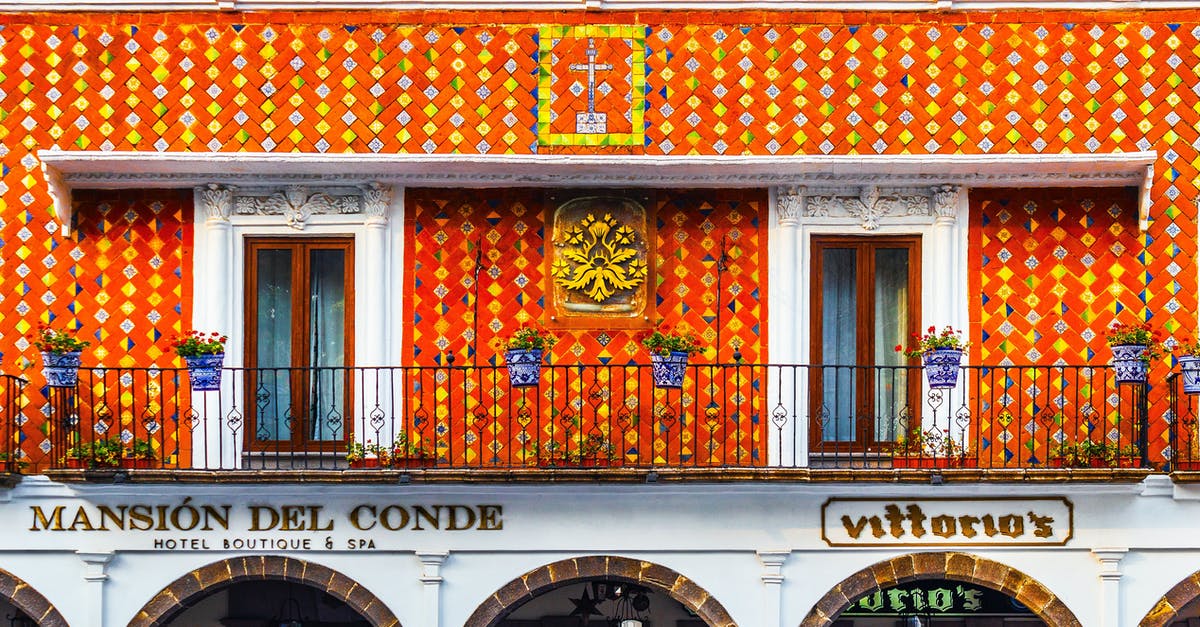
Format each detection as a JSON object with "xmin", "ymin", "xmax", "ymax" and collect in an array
[{"xmin": 0, "ymin": 355, "xmax": 1180, "ymax": 480}]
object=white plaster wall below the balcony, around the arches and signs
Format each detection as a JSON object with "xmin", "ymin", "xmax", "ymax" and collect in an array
[{"xmin": 0, "ymin": 477, "xmax": 1200, "ymax": 627}]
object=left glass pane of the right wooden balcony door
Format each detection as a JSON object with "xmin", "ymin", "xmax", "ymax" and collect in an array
[{"xmin": 821, "ymin": 249, "xmax": 858, "ymax": 442}]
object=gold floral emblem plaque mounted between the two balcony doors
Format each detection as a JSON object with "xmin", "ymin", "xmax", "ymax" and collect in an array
[{"xmin": 546, "ymin": 195, "xmax": 654, "ymax": 328}]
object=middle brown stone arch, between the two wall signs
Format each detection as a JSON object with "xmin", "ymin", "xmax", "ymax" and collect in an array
[{"xmin": 463, "ymin": 555, "xmax": 737, "ymax": 627}]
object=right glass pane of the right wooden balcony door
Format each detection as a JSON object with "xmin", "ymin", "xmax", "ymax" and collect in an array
[{"xmin": 875, "ymin": 249, "xmax": 908, "ymax": 442}]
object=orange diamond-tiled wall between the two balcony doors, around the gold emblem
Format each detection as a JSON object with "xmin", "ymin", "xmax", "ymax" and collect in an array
[{"xmin": 404, "ymin": 184, "xmax": 767, "ymax": 462}]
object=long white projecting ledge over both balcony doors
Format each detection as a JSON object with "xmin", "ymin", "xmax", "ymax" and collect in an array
[{"xmin": 37, "ymin": 150, "xmax": 1157, "ymax": 234}]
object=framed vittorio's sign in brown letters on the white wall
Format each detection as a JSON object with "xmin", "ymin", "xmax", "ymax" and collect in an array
[{"xmin": 821, "ymin": 497, "xmax": 1074, "ymax": 547}]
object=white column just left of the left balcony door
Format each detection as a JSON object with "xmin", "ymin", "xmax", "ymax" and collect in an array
[{"xmin": 192, "ymin": 183, "xmax": 240, "ymax": 468}]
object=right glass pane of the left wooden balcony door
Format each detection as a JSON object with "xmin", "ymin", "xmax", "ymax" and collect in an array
[{"xmin": 308, "ymin": 249, "xmax": 346, "ymax": 441}]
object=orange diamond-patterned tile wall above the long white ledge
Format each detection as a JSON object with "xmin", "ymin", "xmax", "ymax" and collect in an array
[{"xmin": 0, "ymin": 11, "xmax": 1200, "ymax": 466}]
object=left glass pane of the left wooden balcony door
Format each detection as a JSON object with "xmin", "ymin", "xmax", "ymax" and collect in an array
[{"xmin": 254, "ymin": 249, "xmax": 294, "ymax": 441}]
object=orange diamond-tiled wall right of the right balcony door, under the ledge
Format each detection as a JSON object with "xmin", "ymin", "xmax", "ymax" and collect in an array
[{"xmin": 968, "ymin": 184, "xmax": 1171, "ymax": 464}]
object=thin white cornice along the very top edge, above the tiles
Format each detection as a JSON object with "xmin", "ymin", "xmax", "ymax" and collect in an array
[{"xmin": 0, "ymin": 0, "xmax": 1195, "ymax": 12}]
